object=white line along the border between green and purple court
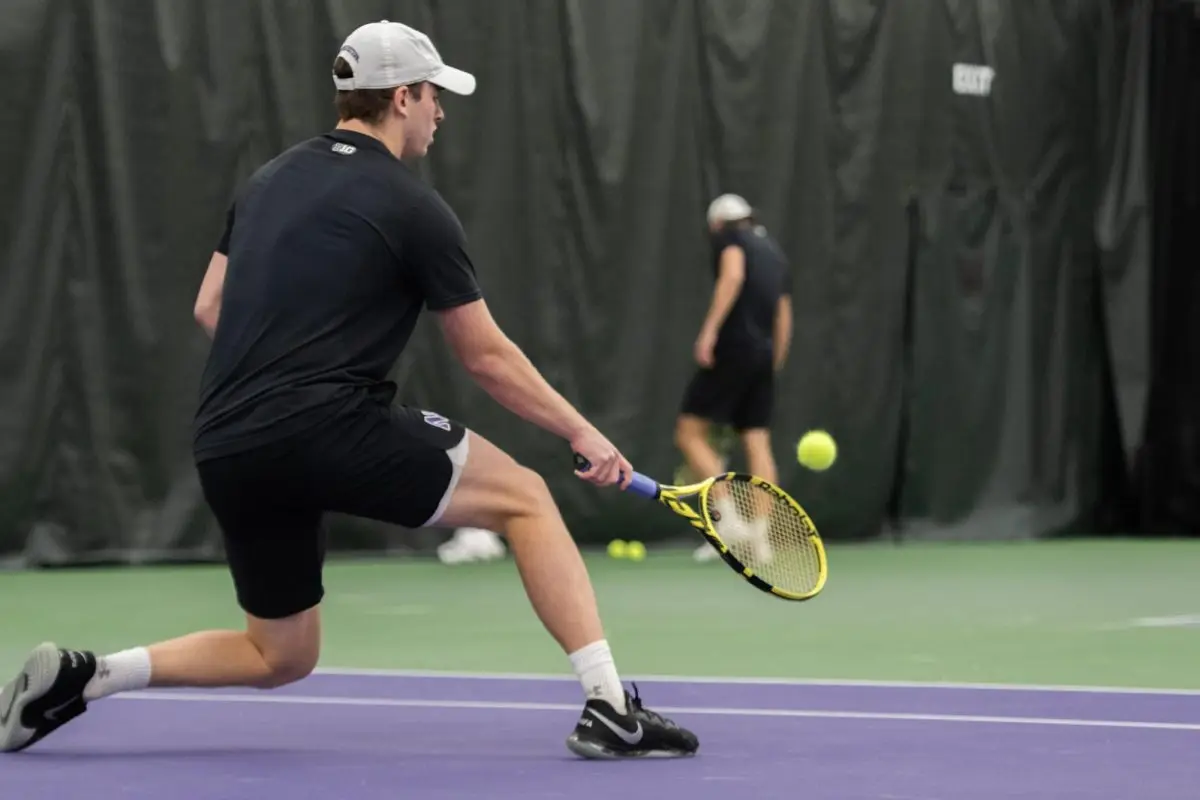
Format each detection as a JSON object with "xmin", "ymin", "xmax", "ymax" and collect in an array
[{"xmin": 313, "ymin": 667, "xmax": 1200, "ymax": 697}]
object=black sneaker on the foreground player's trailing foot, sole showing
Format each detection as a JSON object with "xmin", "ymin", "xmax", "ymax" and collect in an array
[{"xmin": 0, "ymin": 643, "xmax": 96, "ymax": 752}]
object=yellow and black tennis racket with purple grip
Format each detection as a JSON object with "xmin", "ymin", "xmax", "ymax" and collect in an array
[{"xmin": 575, "ymin": 453, "xmax": 828, "ymax": 600}]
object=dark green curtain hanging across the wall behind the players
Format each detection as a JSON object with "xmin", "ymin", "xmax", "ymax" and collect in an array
[{"xmin": 0, "ymin": 0, "xmax": 1151, "ymax": 564}]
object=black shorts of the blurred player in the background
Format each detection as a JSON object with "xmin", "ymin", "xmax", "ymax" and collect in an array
[{"xmin": 679, "ymin": 357, "xmax": 775, "ymax": 431}]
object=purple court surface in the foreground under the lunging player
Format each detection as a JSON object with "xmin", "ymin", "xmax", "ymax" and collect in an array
[{"xmin": 0, "ymin": 673, "xmax": 1200, "ymax": 800}]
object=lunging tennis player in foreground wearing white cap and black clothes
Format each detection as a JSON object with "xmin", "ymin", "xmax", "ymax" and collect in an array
[{"xmin": 0, "ymin": 20, "xmax": 698, "ymax": 758}]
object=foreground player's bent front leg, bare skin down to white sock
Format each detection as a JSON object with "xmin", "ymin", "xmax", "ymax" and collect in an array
[{"xmin": 439, "ymin": 431, "xmax": 625, "ymax": 710}]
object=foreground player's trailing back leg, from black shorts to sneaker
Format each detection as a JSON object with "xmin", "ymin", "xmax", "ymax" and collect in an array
[{"xmin": 0, "ymin": 457, "xmax": 323, "ymax": 752}]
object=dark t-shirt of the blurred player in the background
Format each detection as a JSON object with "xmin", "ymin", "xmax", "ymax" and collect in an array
[{"xmin": 713, "ymin": 225, "xmax": 792, "ymax": 362}]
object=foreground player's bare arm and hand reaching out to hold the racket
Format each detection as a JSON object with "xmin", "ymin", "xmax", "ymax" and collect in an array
[{"xmin": 438, "ymin": 300, "xmax": 632, "ymax": 488}]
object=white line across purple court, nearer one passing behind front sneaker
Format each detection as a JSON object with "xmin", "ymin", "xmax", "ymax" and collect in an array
[{"xmin": 114, "ymin": 692, "xmax": 1200, "ymax": 730}]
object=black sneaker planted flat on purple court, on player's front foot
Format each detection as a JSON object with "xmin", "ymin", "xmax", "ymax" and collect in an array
[{"xmin": 566, "ymin": 684, "xmax": 700, "ymax": 758}]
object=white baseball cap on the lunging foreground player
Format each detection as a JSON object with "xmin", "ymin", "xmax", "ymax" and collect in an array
[{"xmin": 334, "ymin": 19, "xmax": 475, "ymax": 95}]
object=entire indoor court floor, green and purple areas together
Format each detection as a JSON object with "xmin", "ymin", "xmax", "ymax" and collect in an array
[{"xmin": 0, "ymin": 541, "xmax": 1200, "ymax": 800}]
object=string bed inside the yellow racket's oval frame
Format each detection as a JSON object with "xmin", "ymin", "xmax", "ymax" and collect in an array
[{"xmin": 704, "ymin": 480, "xmax": 821, "ymax": 594}]
